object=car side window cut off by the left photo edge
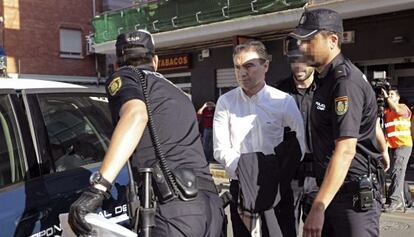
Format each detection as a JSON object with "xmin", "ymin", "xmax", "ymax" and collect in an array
[{"xmin": 0, "ymin": 95, "xmax": 26, "ymax": 188}]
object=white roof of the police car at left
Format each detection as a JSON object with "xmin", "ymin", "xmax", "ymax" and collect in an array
[{"xmin": 0, "ymin": 78, "xmax": 87, "ymax": 90}]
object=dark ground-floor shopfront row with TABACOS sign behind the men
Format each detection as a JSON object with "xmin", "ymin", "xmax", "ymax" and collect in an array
[{"xmin": 98, "ymin": 9, "xmax": 414, "ymax": 108}]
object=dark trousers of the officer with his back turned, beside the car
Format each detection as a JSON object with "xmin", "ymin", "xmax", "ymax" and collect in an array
[{"xmin": 152, "ymin": 191, "xmax": 224, "ymax": 237}]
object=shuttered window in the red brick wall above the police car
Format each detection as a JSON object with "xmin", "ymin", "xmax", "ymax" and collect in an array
[{"xmin": 60, "ymin": 29, "xmax": 82, "ymax": 58}]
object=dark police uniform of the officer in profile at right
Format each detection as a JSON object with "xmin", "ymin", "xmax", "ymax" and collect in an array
[{"xmin": 311, "ymin": 54, "xmax": 380, "ymax": 237}]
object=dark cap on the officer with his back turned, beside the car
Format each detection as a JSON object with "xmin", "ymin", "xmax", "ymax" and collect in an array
[{"xmin": 115, "ymin": 30, "xmax": 155, "ymax": 57}]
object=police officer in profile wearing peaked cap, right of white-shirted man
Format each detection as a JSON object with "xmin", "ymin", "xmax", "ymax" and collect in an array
[{"xmin": 290, "ymin": 9, "xmax": 381, "ymax": 237}]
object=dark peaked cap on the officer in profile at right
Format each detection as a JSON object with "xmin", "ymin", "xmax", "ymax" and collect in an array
[{"xmin": 289, "ymin": 8, "xmax": 344, "ymax": 40}]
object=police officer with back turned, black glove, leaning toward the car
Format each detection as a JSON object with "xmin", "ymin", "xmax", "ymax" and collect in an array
[{"xmin": 69, "ymin": 30, "xmax": 223, "ymax": 237}]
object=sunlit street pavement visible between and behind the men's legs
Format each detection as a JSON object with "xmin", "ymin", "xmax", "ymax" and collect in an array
[{"xmin": 210, "ymin": 163, "xmax": 414, "ymax": 237}]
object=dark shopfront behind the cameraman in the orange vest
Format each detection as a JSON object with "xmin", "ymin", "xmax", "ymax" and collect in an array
[{"xmin": 343, "ymin": 10, "xmax": 414, "ymax": 106}]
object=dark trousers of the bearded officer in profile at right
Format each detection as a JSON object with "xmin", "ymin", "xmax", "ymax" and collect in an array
[{"xmin": 322, "ymin": 193, "xmax": 381, "ymax": 237}]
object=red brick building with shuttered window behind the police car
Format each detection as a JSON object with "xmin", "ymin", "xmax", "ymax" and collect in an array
[{"xmin": 0, "ymin": 0, "xmax": 102, "ymax": 83}]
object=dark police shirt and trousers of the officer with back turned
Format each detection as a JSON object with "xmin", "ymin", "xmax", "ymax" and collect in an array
[{"xmin": 106, "ymin": 65, "xmax": 224, "ymax": 237}]
